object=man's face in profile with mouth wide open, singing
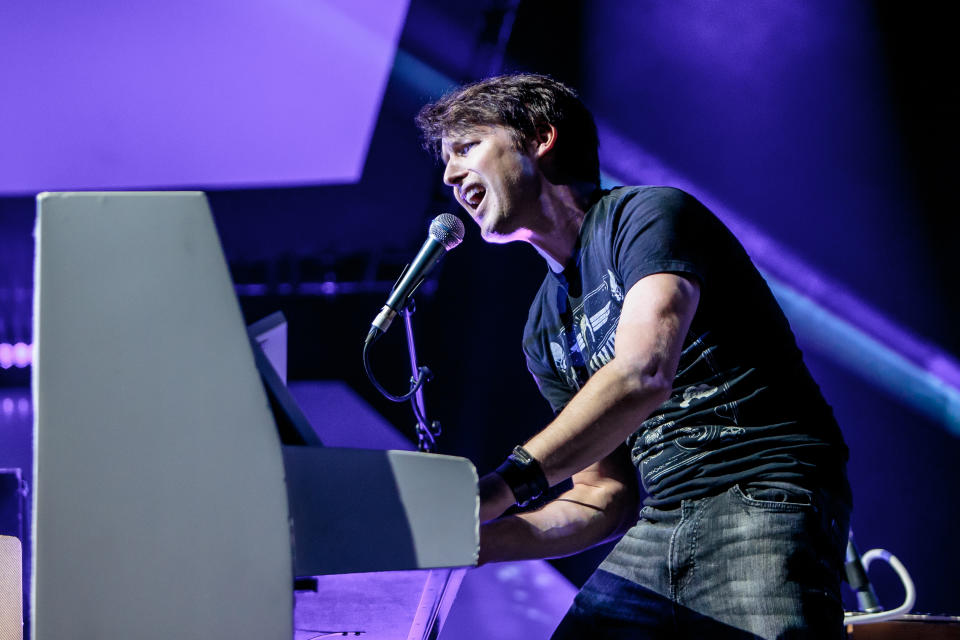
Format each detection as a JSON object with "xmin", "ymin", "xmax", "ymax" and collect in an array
[{"xmin": 441, "ymin": 126, "xmax": 541, "ymax": 242}]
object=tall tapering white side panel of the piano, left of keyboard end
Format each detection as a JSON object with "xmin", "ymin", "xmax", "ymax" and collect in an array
[{"xmin": 32, "ymin": 193, "xmax": 293, "ymax": 640}]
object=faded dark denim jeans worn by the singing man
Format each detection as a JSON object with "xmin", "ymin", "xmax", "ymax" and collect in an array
[{"xmin": 553, "ymin": 482, "xmax": 850, "ymax": 640}]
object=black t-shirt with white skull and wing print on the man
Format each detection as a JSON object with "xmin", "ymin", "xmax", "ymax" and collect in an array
[{"xmin": 523, "ymin": 187, "xmax": 847, "ymax": 506}]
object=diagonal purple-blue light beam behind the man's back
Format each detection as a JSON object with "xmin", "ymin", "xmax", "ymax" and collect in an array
[{"xmin": 598, "ymin": 120, "xmax": 960, "ymax": 435}]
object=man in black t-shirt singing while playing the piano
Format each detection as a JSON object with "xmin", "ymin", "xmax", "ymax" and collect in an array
[{"xmin": 417, "ymin": 74, "xmax": 851, "ymax": 639}]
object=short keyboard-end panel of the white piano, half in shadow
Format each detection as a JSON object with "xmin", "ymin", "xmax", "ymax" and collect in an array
[{"xmin": 283, "ymin": 447, "xmax": 480, "ymax": 576}]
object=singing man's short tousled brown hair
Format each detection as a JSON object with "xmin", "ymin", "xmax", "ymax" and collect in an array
[{"xmin": 416, "ymin": 73, "xmax": 600, "ymax": 186}]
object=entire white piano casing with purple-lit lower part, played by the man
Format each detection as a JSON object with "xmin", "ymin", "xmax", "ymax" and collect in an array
[{"xmin": 31, "ymin": 192, "xmax": 478, "ymax": 640}]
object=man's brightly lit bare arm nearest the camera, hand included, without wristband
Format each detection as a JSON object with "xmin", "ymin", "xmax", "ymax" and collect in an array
[{"xmin": 480, "ymin": 273, "xmax": 700, "ymax": 524}]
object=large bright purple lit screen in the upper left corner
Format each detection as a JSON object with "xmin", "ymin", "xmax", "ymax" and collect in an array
[{"xmin": 0, "ymin": 0, "xmax": 409, "ymax": 193}]
